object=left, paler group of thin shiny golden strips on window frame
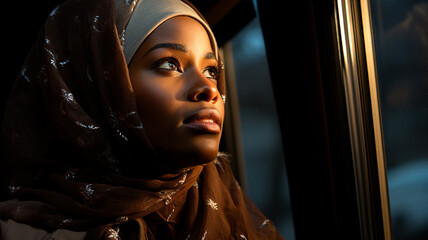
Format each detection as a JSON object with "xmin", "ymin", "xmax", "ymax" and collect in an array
[{"xmin": 335, "ymin": 0, "xmax": 374, "ymax": 239}]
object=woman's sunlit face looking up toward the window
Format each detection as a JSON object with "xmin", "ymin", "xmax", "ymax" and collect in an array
[{"xmin": 129, "ymin": 16, "xmax": 224, "ymax": 167}]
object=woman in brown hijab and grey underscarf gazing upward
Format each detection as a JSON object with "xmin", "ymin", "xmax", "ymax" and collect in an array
[{"xmin": 0, "ymin": 0, "xmax": 282, "ymax": 240}]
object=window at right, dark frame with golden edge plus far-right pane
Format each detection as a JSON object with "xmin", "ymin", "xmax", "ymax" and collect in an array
[{"xmin": 242, "ymin": 0, "xmax": 428, "ymax": 240}]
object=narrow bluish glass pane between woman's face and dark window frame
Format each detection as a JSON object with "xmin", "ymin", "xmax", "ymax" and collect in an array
[{"xmin": 231, "ymin": 16, "xmax": 295, "ymax": 240}]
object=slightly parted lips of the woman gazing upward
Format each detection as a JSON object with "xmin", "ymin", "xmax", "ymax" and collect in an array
[{"xmin": 183, "ymin": 109, "xmax": 221, "ymax": 134}]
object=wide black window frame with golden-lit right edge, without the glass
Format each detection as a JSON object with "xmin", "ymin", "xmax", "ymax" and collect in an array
[{"xmin": 257, "ymin": 0, "xmax": 392, "ymax": 239}]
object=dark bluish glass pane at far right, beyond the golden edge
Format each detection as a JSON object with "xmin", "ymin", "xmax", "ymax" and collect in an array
[{"xmin": 372, "ymin": 0, "xmax": 428, "ymax": 240}]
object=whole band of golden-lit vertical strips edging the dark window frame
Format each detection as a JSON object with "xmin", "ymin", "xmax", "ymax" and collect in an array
[{"xmin": 335, "ymin": 0, "xmax": 392, "ymax": 240}]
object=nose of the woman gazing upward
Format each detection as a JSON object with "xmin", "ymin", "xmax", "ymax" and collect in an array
[{"xmin": 187, "ymin": 74, "xmax": 219, "ymax": 103}]
